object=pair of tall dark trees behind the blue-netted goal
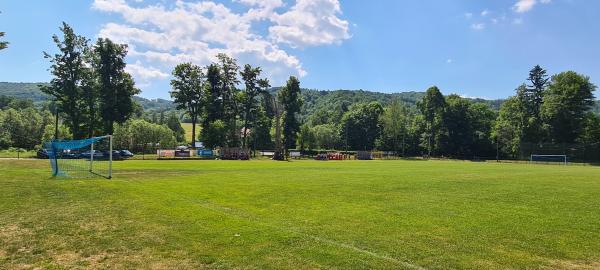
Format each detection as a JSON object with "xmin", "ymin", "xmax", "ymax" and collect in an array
[{"xmin": 41, "ymin": 23, "xmax": 139, "ymax": 139}]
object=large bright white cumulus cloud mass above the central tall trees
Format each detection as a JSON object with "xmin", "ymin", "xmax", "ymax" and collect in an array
[{"xmin": 92, "ymin": 0, "xmax": 350, "ymax": 91}]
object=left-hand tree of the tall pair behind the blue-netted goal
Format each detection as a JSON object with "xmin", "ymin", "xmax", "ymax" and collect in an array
[{"xmin": 41, "ymin": 22, "xmax": 88, "ymax": 139}]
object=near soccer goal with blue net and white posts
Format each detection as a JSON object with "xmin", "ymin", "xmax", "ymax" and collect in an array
[{"xmin": 45, "ymin": 135, "xmax": 113, "ymax": 179}]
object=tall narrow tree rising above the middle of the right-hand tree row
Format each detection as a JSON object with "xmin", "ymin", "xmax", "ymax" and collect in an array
[{"xmin": 417, "ymin": 86, "xmax": 446, "ymax": 156}]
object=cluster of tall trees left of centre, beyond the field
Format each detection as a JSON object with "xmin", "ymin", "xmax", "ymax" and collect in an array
[{"xmin": 170, "ymin": 54, "xmax": 302, "ymax": 152}]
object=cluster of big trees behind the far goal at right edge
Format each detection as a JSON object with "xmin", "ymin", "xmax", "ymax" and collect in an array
[{"xmin": 493, "ymin": 66, "xmax": 600, "ymax": 155}]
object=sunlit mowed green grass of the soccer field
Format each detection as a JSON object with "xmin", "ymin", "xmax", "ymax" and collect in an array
[{"xmin": 0, "ymin": 160, "xmax": 600, "ymax": 269}]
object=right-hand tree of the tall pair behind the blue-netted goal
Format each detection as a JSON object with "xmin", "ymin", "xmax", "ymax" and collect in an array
[{"xmin": 93, "ymin": 38, "xmax": 140, "ymax": 134}]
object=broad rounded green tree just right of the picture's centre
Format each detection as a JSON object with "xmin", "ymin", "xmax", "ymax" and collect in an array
[{"xmin": 340, "ymin": 101, "xmax": 383, "ymax": 150}]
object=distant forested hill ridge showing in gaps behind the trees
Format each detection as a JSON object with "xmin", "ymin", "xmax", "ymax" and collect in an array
[{"xmin": 0, "ymin": 82, "xmax": 600, "ymax": 116}]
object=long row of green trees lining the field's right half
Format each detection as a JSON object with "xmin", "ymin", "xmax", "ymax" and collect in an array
[{"xmin": 298, "ymin": 66, "xmax": 600, "ymax": 158}]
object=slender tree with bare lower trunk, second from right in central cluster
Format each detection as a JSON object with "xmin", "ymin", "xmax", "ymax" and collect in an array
[{"xmin": 240, "ymin": 65, "xmax": 269, "ymax": 148}]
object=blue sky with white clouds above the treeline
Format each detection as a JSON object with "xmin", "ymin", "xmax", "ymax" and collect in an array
[{"xmin": 0, "ymin": 0, "xmax": 600, "ymax": 98}]
